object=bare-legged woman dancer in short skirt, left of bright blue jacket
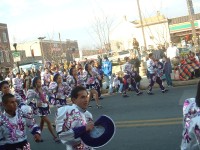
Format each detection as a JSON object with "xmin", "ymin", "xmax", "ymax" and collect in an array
[{"xmin": 83, "ymin": 63, "xmax": 102, "ymax": 108}]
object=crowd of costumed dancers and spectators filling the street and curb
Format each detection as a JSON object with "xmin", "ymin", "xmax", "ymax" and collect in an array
[{"xmin": 0, "ymin": 39, "xmax": 199, "ymax": 150}]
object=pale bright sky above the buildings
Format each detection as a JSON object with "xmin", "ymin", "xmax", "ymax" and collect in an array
[{"xmin": 0, "ymin": 0, "xmax": 200, "ymax": 48}]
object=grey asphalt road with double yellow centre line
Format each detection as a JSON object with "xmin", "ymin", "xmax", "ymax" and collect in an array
[{"xmin": 29, "ymin": 86, "xmax": 196, "ymax": 150}]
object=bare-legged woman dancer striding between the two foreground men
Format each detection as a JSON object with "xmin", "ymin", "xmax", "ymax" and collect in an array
[{"xmin": 27, "ymin": 77, "xmax": 59, "ymax": 142}]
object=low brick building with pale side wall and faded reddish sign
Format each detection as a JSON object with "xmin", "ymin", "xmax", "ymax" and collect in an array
[{"xmin": 12, "ymin": 39, "xmax": 79, "ymax": 64}]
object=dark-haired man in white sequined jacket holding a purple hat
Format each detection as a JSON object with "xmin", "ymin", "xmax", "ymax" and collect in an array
[{"xmin": 56, "ymin": 86, "xmax": 94, "ymax": 150}]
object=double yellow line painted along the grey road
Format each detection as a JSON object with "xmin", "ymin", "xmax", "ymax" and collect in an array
[{"xmin": 115, "ymin": 118, "xmax": 183, "ymax": 124}]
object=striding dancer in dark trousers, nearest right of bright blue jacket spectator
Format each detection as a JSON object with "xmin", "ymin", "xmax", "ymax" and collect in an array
[{"xmin": 122, "ymin": 57, "xmax": 142, "ymax": 97}]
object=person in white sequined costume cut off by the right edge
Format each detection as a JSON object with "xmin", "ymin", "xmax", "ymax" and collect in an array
[{"xmin": 181, "ymin": 82, "xmax": 200, "ymax": 150}]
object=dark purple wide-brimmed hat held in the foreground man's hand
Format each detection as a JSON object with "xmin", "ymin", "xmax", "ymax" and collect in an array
[{"xmin": 81, "ymin": 115, "xmax": 115, "ymax": 148}]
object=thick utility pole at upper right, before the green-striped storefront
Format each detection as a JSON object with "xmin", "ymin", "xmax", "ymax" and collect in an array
[{"xmin": 187, "ymin": 0, "xmax": 198, "ymax": 53}]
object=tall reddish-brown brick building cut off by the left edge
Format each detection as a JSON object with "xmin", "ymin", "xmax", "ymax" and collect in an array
[{"xmin": 0, "ymin": 23, "xmax": 13, "ymax": 74}]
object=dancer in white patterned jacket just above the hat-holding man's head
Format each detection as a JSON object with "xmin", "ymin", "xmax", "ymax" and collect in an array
[{"xmin": 67, "ymin": 67, "xmax": 85, "ymax": 89}]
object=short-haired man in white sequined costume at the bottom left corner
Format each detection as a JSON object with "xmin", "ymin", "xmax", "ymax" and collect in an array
[{"xmin": 0, "ymin": 93, "xmax": 41, "ymax": 150}]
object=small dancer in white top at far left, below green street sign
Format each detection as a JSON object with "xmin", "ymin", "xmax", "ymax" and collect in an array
[{"xmin": 13, "ymin": 73, "xmax": 26, "ymax": 101}]
